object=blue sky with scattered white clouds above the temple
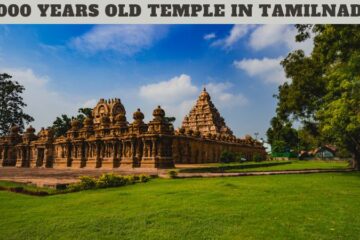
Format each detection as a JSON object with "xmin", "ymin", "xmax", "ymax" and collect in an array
[{"xmin": 0, "ymin": 25, "xmax": 312, "ymax": 139}]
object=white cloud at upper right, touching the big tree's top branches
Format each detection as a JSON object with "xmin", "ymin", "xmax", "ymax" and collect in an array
[{"xmin": 249, "ymin": 24, "xmax": 314, "ymax": 54}]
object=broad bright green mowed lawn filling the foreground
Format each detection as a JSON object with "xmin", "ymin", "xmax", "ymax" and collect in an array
[{"xmin": 0, "ymin": 173, "xmax": 360, "ymax": 240}]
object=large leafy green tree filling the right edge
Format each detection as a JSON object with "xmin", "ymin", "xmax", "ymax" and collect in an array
[{"xmin": 276, "ymin": 25, "xmax": 360, "ymax": 170}]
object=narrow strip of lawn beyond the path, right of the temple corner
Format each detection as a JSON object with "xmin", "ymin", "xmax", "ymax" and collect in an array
[{"xmin": 179, "ymin": 160, "xmax": 349, "ymax": 173}]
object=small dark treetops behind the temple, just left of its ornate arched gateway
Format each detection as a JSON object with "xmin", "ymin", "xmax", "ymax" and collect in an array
[{"xmin": 52, "ymin": 108, "xmax": 92, "ymax": 137}]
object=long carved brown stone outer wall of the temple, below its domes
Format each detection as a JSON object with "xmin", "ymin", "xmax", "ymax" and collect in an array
[{"xmin": 0, "ymin": 135, "xmax": 266, "ymax": 169}]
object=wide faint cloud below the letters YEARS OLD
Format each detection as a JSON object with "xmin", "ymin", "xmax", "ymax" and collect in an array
[{"xmin": 71, "ymin": 25, "xmax": 166, "ymax": 56}]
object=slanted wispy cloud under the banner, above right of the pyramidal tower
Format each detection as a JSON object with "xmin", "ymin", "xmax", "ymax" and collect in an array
[{"xmin": 212, "ymin": 25, "xmax": 253, "ymax": 49}]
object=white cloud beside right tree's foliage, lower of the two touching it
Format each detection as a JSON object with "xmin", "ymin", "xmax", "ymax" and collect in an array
[{"xmin": 234, "ymin": 57, "xmax": 287, "ymax": 84}]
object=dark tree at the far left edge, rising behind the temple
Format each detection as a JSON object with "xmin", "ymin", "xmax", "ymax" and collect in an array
[{"xmin": 0, "ymin": 73, "xmax": 34, "ymax": 136}]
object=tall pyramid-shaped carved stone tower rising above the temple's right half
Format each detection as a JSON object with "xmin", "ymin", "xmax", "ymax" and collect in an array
[{"xmin": 182, "ymin": 88, "xmax": 233, "ymax": 136}]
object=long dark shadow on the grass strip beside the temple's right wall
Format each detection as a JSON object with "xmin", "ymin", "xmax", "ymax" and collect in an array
[{"xmin": 179, "ymin": 162, "xmax": 292, "ymax": 173}]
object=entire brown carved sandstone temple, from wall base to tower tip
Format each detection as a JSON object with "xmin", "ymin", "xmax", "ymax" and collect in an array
[{"xmin": 0, "ymin": 89, "xmax": 266, "ymax": 168}]
